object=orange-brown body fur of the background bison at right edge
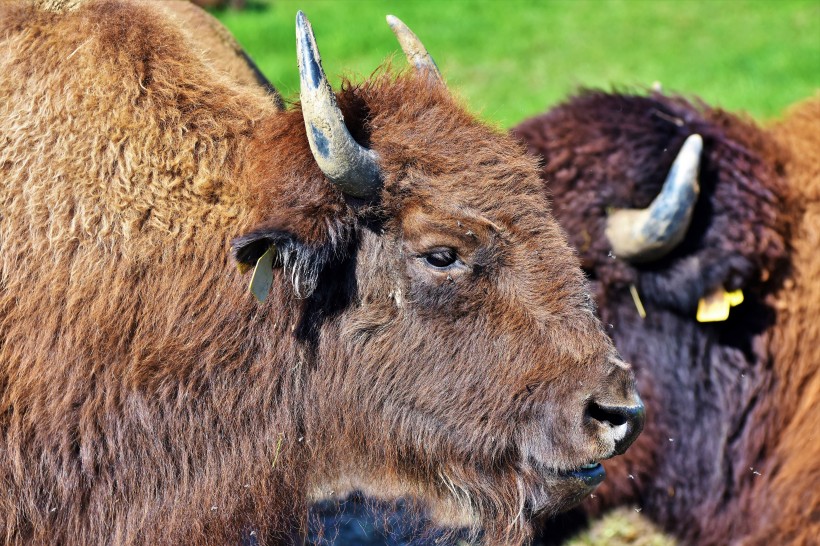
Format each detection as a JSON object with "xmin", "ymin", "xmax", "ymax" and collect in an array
[{"xmin": 748, "ymin": 96, "xmax": 820, "ymax": 546}]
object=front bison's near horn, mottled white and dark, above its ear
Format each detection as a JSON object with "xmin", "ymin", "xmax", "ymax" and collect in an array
[{"xmin": 296, "ymin": 11, "xmax": 381, "ymax": 198}]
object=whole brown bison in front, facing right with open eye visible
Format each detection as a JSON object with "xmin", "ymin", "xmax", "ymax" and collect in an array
[{"xmin": 0, "ymin": 0, "xmax": 643, "ymax": 544}]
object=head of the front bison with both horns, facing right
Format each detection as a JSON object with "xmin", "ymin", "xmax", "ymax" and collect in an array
[{"xmin": 229, "ymin": 13, "xmax": 643, "ymax": 542}]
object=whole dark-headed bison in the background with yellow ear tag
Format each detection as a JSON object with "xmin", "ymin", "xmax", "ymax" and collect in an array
[{"xmin": 513, "ymin": 92, "xmax": 820, "ymax": 545}]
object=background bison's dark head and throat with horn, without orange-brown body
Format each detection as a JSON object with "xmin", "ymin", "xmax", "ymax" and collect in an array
[{"xmin": 513, "ymin": 91, "xmax": 789, "ymax": 542}]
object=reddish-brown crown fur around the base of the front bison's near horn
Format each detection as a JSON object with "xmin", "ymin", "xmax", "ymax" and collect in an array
[{"xmin": 246, "ymin": 70, "xmax": 558, "ymax": 239}]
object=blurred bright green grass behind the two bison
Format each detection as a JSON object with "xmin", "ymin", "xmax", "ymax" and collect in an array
[{"xmin": 215, "ymin": 0, "xmax": 820, "ymax": 127}]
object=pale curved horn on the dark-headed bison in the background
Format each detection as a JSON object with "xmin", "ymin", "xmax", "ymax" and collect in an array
[{"xmin": 606, "ymin": 135, "xmax": 703, "ymax": 262}]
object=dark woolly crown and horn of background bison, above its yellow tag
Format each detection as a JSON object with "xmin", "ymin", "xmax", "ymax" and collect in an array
[{"xmin": 513, "ymin": 92, "xmax": 787, "ymax": 315}]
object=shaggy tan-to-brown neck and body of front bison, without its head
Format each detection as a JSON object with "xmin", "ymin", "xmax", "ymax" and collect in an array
[{"xmin": 0, "ymin": 2, "xmax": 330, "ymax": 544}]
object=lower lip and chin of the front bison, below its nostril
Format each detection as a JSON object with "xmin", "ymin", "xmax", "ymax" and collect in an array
[{"xmin": 525, "ymin": 459, "xmax": 606, "ymax": 517}]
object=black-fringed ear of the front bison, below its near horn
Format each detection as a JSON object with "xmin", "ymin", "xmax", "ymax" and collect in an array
[{"xmin": 231, "ymin": 222, "xmax": 348, "ymax": 299}]
